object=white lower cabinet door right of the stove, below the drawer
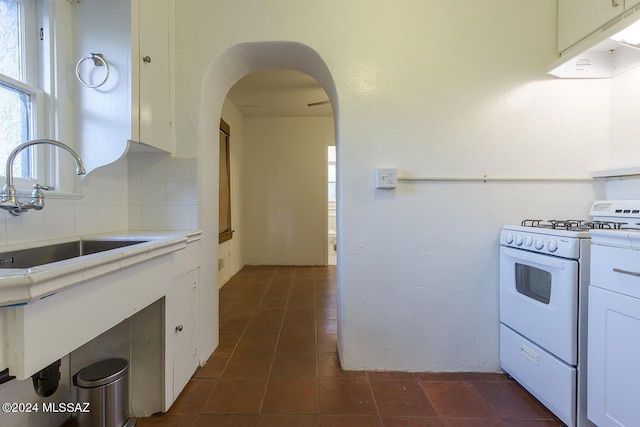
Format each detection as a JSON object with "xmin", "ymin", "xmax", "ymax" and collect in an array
[{"xmin": 587, "ymin": 286, "xmax": 640, "ymax": 427}]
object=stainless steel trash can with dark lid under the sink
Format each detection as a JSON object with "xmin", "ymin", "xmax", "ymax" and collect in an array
[{"xmin": 74, "ymin": 359, "xmax": 135, "ymax": 427}]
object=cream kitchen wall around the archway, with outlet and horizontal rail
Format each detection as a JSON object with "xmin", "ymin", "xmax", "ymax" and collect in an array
[{"xmin": 176, "ymin": 0, "xmax": 610, "ymax": 371}]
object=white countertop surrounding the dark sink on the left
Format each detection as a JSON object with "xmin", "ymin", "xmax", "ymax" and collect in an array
[{"xmin": 0, "ymin": 231, "xmax": 201, "ymax": 306}]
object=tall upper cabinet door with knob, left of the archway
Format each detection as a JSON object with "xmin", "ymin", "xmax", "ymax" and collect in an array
[{"xmin": 138, "ymin": 0, "xmax": 174, "ymax": 152}]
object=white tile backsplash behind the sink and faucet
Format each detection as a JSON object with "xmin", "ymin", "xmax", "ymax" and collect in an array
[{"xmin": 0, "ymin": 152, "xmax": 198, "ymax": 246}]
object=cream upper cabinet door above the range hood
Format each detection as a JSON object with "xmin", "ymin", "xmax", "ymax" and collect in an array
[{"xmin": 558, "ymin": 0, "xmax": 631, "ymax": 52}]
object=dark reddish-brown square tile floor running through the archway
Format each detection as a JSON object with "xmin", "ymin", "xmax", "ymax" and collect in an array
[{"xmin": 138, "ymin": 267, "xmax": 562, "ymax": 427}]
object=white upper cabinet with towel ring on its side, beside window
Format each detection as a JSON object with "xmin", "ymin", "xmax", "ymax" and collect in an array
[{"xmin": 72, "ymin": 0, "xmax": 175, "ymax": 175}]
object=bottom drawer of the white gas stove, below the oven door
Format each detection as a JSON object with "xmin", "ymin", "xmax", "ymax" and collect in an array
[{"xmin": 500, "ymin": 324, "xmax": 576, "ymax": 427}]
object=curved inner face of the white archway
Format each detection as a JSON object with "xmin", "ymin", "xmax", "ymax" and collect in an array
[{"xmin": 198, "ymin": 41, "xmax": 342, "ymax": 364}]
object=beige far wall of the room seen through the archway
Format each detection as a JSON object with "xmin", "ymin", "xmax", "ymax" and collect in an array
[{"xmin": 243, "ymin": 117, "xmax": 334, "ymax": 265}]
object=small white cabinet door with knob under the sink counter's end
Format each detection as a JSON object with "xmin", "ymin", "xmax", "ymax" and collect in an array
[{"xmin": 173, "ymin": 269, "xmax": 198, "ymax": 399}]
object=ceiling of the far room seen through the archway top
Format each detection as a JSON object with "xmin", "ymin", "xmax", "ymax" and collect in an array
[{"xmin": 227, "ymin": 69, "xmax": 333, "ymax": 117}]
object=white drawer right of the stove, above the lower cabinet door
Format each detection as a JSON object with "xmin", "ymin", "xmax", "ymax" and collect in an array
[{"xmin": 591, "ymin": 245, "xmax": 640, "ymax": 298}]
